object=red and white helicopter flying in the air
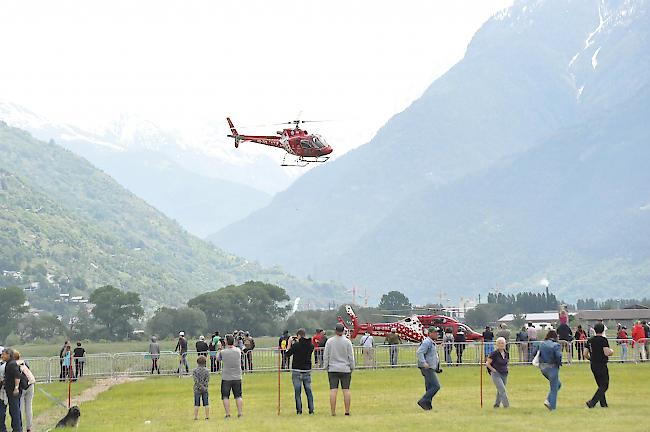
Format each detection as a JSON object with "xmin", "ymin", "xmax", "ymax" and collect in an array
[{"xmin": 226, "ymin": 117, "xmax": 332, "ymax": 167}]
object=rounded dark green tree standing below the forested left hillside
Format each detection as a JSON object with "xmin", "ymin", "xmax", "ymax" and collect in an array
[{"xmin": 89, "ymin": 285, "xmax": 144, "ymax": 339}]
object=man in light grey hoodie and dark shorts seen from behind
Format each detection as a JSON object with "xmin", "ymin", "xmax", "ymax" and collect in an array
[{"xmin": 323, "ymin": 323, "xmax": 354, "ymax": 416}]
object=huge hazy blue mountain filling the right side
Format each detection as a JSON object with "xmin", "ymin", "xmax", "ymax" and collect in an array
[{"xmin": 210, "ymin": 0, "xmax": 650, "ymax": 301}]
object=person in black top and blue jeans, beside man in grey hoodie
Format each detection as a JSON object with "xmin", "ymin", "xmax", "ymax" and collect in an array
[{"xmin": 287, "ymin": 329, "xmax": 314, "ymax": 414}]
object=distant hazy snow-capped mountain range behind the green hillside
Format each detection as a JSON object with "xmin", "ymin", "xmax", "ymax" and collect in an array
[{"xmin": 0, "ymin": 102, "xmax": 282, "ymax": 237}]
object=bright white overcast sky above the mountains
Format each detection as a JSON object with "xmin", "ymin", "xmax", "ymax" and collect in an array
[{"xmin": 0, "ymin": 0, "xmax": 512, "ymax": 155}]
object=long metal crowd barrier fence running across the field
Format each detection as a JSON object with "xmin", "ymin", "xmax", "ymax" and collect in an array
[{"xmin": 26, "ymin": 339, "xmax": 650, "ymax": 382}]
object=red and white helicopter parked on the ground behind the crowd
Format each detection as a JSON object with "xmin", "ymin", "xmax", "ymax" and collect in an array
[{"xmin": 338, "ymin": 305, "xmax": 483, "ymax": 342}]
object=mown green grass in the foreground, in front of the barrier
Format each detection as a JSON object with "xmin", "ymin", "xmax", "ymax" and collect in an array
[{"xmin": 44, "ymin": 364, "xmax": 650, "ymax": 432}]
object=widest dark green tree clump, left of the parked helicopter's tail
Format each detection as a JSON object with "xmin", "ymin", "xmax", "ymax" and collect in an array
[{"xmin": 187, "ymin": 281, "xmax": 291, "ymax": 335}]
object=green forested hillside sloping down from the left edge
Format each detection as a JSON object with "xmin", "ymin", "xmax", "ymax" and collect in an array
[{"xmin": 0, "ymin": 122, "xmax": 342, "ymax": 310}]
